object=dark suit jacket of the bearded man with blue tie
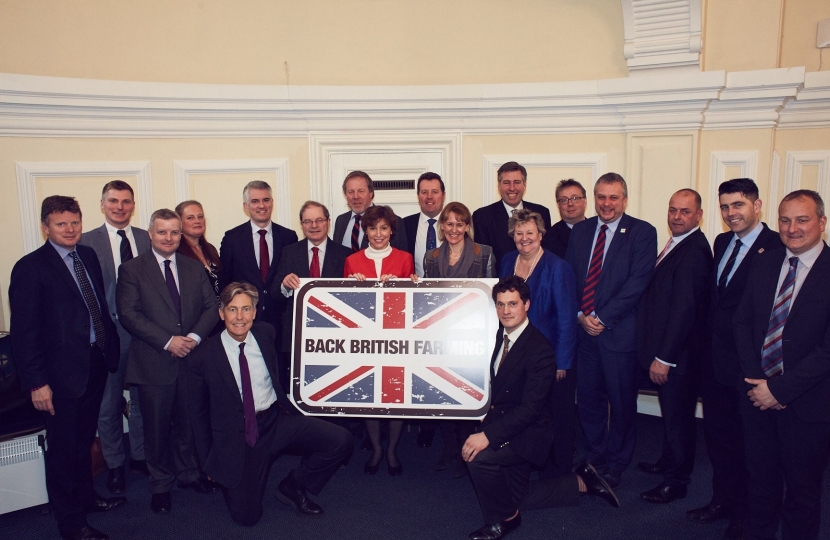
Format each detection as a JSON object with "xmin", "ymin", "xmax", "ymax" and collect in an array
[{"xmin": 709, "ymin": 223, "xmax": 783, "ymax": 388}]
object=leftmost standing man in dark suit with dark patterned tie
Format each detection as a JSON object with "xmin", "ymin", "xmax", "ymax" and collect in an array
[{"xmin": 9, "ymin": 195, "xmax": 127, "ymax": 540}]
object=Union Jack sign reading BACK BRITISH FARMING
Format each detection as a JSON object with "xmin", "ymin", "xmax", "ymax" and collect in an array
[{"xmin": 291, "ymin": 279, "xmax": 498, "ymax": 418}]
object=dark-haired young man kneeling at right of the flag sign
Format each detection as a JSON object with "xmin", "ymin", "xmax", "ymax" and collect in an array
[{"xmin": 461, "ymin": 276, "xmax": 620, "ymax": 540}]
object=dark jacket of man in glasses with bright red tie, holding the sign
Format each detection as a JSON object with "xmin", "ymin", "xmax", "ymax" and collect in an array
[{"xmin": 274, "ymin": 238, "xmax": 352, "ymax": 352}]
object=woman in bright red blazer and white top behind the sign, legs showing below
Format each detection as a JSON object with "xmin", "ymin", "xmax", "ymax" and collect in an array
[{"xmin": 343, "ymin": 206, "xmax": 415, "ymax": 476}]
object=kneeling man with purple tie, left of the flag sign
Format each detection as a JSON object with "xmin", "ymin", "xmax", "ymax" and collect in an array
[{"xmin": 189, "ymin": 283, "xmax": 352, "ymax": 526}]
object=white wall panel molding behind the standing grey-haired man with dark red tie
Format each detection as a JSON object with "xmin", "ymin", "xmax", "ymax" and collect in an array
[{"xmin": 173, "ymin": 158, "xmax": 291, "ymax": 229}]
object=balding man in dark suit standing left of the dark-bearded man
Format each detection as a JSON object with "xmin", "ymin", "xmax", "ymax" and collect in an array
[{"xmin": 637, "ymin": 189, "xmax": 712, "ymax": 503}]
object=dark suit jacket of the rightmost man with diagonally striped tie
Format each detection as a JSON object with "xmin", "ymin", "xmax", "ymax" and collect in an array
[{"xmin": 734, "ymin": 244, "xmax": 830, "ymax": 422}]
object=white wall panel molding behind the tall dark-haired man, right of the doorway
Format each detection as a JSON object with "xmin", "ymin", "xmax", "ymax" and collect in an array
[{"xmin": 481, "ymin": 154, "xmax": 607, "ymax": 210}]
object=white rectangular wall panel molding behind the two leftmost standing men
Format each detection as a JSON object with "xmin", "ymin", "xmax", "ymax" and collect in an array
[{"xmin": 15, "ymin": 161, "xmax": 153, "ymax": 253}]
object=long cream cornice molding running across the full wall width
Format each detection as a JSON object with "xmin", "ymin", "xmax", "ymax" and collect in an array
[{"xmin": 0, "ymin": 67, "xmax": 830, "ymax": 138}]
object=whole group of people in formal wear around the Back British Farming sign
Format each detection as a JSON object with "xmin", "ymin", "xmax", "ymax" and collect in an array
[{"xmin": 9, "ymin": 162, "xmax": 830, "ymax": 540}]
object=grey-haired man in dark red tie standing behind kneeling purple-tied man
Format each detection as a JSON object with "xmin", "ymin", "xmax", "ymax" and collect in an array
[{"xmin": 219, "ymin": 180, "xmax": 297, "ymax": 388}]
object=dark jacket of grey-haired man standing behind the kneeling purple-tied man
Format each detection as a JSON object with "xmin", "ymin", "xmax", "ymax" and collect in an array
[{"xmin": 219, "ymin": 221, "xmax": 297, "ymax": 347}]
